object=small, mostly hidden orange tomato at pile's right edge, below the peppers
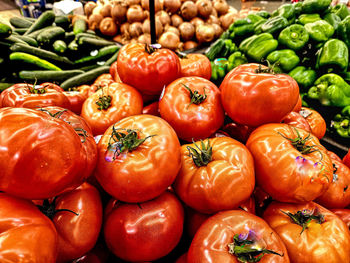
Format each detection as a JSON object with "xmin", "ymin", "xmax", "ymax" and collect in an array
[{"xmin": 299, "ymin": 107, "xmax": 326, "ymax": 139}]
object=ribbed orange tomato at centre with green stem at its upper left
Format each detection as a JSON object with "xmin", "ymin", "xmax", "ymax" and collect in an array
[{"xmin": 174, "ymin": 137, "xmax": 255, "ymax": 214}]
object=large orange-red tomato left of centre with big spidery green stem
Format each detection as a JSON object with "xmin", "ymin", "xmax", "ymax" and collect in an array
[{"xmin": 95, "ymin": 115, "xmax": 181, "ymax": 203}]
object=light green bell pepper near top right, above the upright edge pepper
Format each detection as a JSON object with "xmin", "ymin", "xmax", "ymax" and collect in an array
[{"xmin": 304, "ymin": 20, "xmax": 334, "ymax": 42}]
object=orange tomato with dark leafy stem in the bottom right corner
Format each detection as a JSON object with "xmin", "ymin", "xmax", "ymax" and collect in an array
[{"xmin": 264, "ymin": 202, "xmax": 350, "ymax": 263}]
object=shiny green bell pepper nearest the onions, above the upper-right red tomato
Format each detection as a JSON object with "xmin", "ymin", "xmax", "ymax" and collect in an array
[{"xmin": 239, "ymin": 33, "xmax": 278, "ymax": 62}]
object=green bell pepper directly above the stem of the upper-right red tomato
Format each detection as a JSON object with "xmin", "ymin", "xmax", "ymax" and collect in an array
[{"xmin": 266, "ymin": 49, "xmax": 300, "ymax": 72}]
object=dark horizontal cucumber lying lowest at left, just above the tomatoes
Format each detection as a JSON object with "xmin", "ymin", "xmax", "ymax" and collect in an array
[{"xmin": 19, "ymin": 70, "xmax": 84, "ymax": 82}]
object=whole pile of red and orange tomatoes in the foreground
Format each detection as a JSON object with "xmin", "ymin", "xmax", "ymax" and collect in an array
[{"xmin": 0, "ymin": 44, "xmax": 350, "ymax": 263}]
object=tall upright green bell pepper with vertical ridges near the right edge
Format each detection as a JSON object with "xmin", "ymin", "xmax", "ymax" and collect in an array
[{"xmin": 316, "ymin": 39, "xmax": 349, "ymax": 72}]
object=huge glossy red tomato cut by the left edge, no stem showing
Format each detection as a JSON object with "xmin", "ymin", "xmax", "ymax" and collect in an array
[{"xmin": 0, "ymin": 108, "xmax": 86, "ymax": 199}]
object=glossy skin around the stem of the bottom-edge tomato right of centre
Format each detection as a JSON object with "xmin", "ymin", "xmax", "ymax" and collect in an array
[{"xmin": 187, "ymin": 210, "xmax": 290, "ymax": 263}]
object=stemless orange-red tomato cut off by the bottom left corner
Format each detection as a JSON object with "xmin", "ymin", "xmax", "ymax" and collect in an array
[{"xmin": 0, "ymin": 193, "xmax": 57, "ymax": 263}]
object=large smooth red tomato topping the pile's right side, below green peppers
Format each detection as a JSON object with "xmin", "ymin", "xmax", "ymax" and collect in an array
[{"xmin": 220, "ymin": 64, "xmax": 299, "ymax": 127}]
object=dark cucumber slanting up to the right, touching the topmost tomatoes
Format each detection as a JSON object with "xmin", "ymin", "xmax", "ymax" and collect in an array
[{"xmin": 61, "ymin": 66, "xmax": 109, "ymax": 90}]
